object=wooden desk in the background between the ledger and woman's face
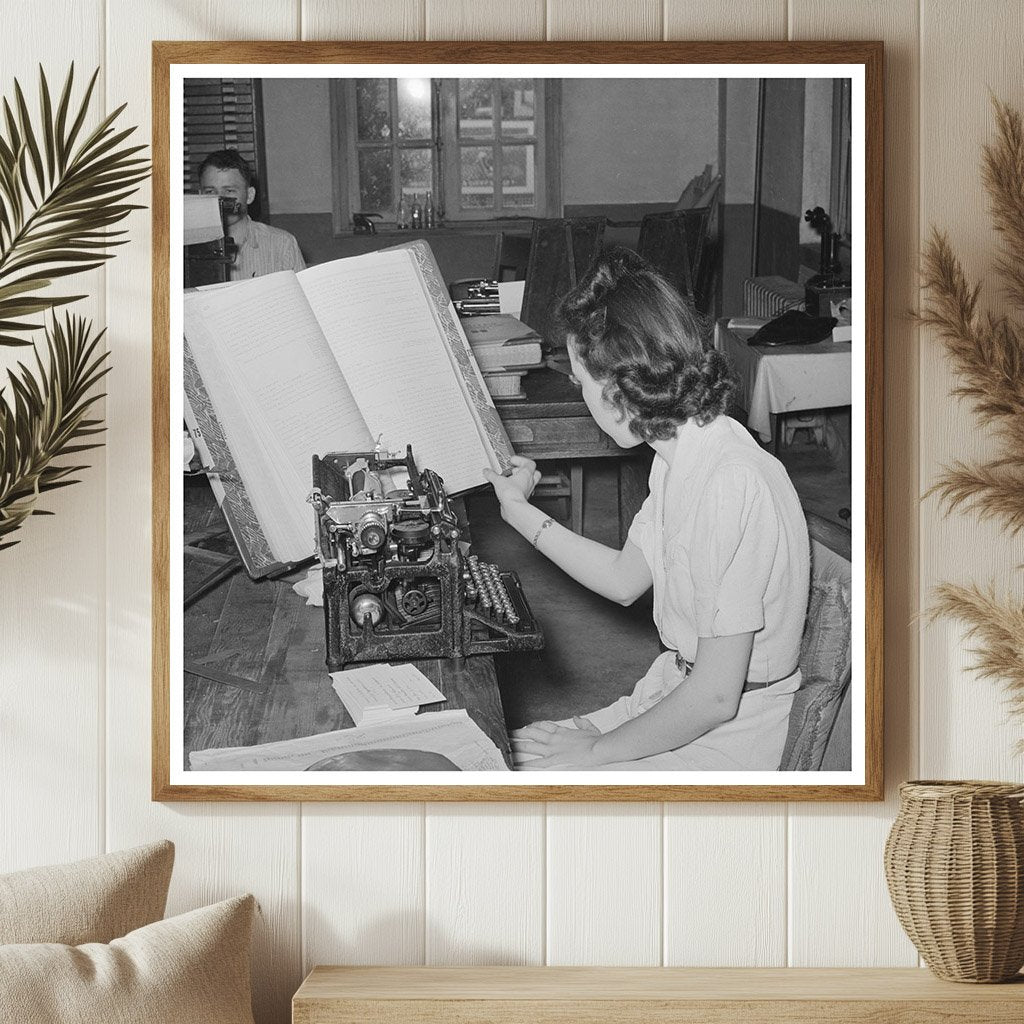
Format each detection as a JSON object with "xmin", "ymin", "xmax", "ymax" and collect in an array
[{"xmin": 497, "ymin": 369, "xmax": 651, "ymax": 543}]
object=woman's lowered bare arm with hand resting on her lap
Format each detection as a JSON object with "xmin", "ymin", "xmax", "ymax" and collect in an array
[{"xmin": 512, "ymin": 633, "xmax": 754, "ymax": 769}]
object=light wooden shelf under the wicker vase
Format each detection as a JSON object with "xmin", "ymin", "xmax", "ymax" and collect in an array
[{"xmin": 292, "ymin": 967, "xmax": 1024, "ymax": 1024}]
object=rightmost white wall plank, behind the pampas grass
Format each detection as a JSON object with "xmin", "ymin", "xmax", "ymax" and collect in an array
[{"xmin": 921, "ymin": 0, "xmax": 1024, "ymax": 778}]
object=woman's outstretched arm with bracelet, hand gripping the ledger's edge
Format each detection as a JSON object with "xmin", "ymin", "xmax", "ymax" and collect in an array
[{"xmin": 484, "ymin": 456, "xmax": 653, "ymax": 604}]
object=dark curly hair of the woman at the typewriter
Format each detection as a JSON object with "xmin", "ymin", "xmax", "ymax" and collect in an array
[{"xmin": 554, "ymin": 248, "xmax": 736, "ymax": 441}]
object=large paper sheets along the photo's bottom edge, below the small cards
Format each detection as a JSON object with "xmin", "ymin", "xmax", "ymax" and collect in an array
[{"xmin": 188, "ymin": 709, "xmax": 509, "ymax": 771}]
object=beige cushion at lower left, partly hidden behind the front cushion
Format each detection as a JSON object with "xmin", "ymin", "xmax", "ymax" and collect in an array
[{"xmin": 0, "ymin": 842, "xmax": 174, "ymax": 946}]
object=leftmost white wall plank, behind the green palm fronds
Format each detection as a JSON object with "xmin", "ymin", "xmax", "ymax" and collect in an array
[{"xmin": 0, "ymin": 0, "xmax": 106, "ymax": 871}]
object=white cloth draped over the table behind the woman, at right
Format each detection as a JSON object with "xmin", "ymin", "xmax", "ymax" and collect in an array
[{"xmin": 715, "ymin": 321, "xmax": 853, "ymax": 442}]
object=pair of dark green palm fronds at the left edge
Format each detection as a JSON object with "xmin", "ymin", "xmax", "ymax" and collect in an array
[{"xmin": 0, "ymin": 65, "xmax": 150, "ymax": 550}]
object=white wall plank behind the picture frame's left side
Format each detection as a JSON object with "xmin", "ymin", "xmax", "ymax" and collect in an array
[{"xmin": 106, "ymin": 0, "xmax": 299, "ymax": 1024}]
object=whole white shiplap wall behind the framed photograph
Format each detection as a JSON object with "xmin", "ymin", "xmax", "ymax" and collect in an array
[{"xmin": 0, "ymin": 0, "xmax": 1024, "ymax": 1024}]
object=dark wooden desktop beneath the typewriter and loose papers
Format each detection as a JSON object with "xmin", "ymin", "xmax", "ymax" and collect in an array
[{"xmin": 183, "ymin": 485, "xmax": 512, "ymax": 769}]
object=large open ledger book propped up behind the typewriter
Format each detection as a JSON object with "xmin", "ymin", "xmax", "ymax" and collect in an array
[{"xmin": 183, "ymin": 241, "xmax": 513, "ymax": 577}]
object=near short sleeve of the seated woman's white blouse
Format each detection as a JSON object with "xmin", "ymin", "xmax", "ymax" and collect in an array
[{"xmin": 689, "ymin": 466, "xmax": 781, "ymax": 637}]
